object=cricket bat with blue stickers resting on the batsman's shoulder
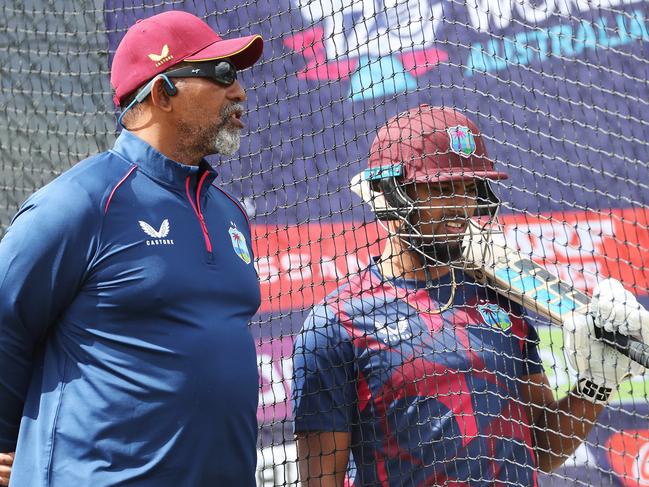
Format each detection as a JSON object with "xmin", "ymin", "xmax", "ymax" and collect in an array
[{"xmin": 464, "ymin": 233, "xmax": 649, "ymax": 368}]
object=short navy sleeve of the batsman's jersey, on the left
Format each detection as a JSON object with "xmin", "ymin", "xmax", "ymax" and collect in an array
[{"xmin": 292, "ymin": 306, "xmax": 357, "ymax": 433}]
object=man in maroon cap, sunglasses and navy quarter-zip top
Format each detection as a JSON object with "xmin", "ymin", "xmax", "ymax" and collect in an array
[{"xmin": 0, "ymin": 11, "xmax": 263, "ymax": 487}]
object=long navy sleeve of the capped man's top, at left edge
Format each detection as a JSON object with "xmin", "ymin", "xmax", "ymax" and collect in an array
[{"xmin": 0, "ymin": 185, "xmax": 99, "ymax": 452}]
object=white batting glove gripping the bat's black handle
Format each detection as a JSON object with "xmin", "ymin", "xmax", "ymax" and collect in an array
[{"xmin": 563, "ymin": 279, "xmax": 649, "ymax": 404}]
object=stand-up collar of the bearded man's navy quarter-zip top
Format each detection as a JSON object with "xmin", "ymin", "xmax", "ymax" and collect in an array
[{"xmin": 112, "ymin": 130, "xmax": 217, "ymax": 187}]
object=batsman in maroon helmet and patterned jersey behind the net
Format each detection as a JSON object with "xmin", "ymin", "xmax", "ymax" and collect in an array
[{"xmin": 293, "ymin": 105, "xmax": 649, "ymax": 487}]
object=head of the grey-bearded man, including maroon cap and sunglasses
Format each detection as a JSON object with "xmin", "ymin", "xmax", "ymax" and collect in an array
[{"xmin": 111, "ymin": 11, "xmax": 263, "ymax": 160}]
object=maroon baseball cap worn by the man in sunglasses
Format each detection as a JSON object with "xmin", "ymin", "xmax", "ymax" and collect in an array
[{"xmin": 110, "ymin": 10, "xmax": 264, "ymax": 106}]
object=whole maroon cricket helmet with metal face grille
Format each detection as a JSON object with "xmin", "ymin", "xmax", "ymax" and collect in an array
[{"xmin": 352, "ymin": 105, "xmax": 508, "ymax": 265}]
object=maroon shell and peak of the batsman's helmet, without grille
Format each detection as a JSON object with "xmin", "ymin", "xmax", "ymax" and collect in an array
[{"xmin": 368, "ymin": 105, "xmax": 508, "ymax": 182}]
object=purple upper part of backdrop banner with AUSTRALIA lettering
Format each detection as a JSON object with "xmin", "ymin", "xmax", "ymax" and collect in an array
[{"xmin": 105, "ymin": 0, "xmax": 649, "ymax": 223}]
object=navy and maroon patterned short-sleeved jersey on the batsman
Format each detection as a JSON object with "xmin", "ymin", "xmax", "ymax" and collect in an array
[{"xmin": 293, "ymin": 258, "xmax": 543, "ymax": 487}]
